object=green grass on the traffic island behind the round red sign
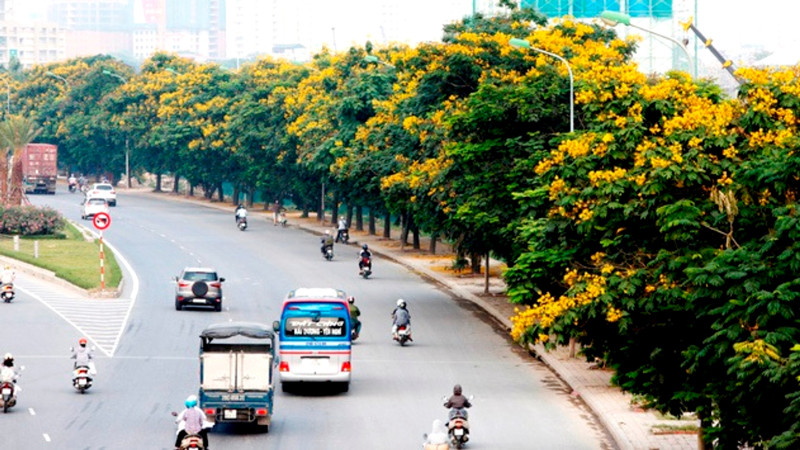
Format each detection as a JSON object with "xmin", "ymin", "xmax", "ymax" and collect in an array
[{"xmin": 0, "ymin": 223, "xmax": 122, "ymax": 290}]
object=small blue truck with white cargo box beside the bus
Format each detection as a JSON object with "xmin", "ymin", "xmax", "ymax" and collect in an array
[{"xmin": 198, "ymin": 322, "xmax": 275, "ymax": 431}]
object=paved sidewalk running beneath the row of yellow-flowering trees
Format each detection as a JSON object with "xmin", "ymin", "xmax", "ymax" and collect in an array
[{"xmin": 128, "ymin": 191, "xmax": 698, "ymax": 450}]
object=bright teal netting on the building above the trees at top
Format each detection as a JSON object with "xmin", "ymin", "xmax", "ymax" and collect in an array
[{"xmin": 522, "ymin": 0, "xmax": 672, "ymax": 19}]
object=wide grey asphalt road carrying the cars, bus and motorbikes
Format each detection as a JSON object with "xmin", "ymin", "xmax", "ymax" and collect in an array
[{"xmin": 0, "ymin": 190, "xmax": 614, "ymax": 450}]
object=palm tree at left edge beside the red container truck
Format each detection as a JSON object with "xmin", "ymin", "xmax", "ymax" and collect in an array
[{"xmin": 0, "ymin": 116, "xmax": 42, "ymax": 206}]
